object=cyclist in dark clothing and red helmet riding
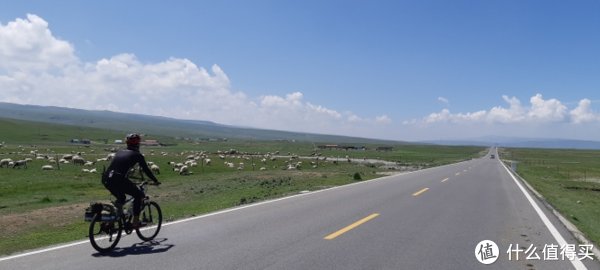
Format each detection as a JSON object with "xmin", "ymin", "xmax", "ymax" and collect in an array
[{"xmin": 102, "ymin": 133, "xmax": 160, "ymax": 228}]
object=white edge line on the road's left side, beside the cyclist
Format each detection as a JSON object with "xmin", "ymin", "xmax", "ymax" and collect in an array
[{"xmin": 0, "ymin": 160, "xmax": 472, "ymax": 262}]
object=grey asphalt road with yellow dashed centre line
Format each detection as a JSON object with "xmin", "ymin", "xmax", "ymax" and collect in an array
[{"xmin": 0, "ymin": 150, "xmax": 600, "ymax": 270}]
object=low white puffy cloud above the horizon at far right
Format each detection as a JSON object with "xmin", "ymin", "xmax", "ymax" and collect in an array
[{"xmin": 412, "ymin": 94, "xmax": 600, "ymax": 125}]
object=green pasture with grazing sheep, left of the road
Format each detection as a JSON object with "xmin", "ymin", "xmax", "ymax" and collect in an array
[{"xmin": 0, "ymin": 135, "xmax": 485, "ymax": 255}]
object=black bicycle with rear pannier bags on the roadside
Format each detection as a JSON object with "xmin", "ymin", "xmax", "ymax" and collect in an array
[{"xmin": 84, "ymin": 181, "xmax": 162, "ymax": 253}]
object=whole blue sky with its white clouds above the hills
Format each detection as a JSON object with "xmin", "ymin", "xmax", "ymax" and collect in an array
[{"xmin": 0, "ymin": 1, "xmax": 600, "ymax": 141}]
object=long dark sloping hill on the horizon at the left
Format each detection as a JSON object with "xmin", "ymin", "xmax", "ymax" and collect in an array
[{"xmin": 0, "ymin": 102, "xmax": 405, "ymax": 144}]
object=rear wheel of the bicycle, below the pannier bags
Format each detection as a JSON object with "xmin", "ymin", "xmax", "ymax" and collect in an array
[{"xmin": 89, "ymin": 213, "xmax": 123, "ymax": 253}]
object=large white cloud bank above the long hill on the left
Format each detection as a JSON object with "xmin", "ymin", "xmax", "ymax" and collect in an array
[{"xmin": 0, "ymin": 15, "xmax": 391, "ymax": 136}]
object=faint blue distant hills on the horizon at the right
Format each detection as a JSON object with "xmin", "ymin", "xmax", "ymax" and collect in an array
[{"xmin": 423, "ymin": 136, "xmax": 600, "ymax": 149}]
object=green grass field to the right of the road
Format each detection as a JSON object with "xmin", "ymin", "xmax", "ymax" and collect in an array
[{"xmin": 500, "ymin": 148, "xmax": 600, "ymax": 249}]
